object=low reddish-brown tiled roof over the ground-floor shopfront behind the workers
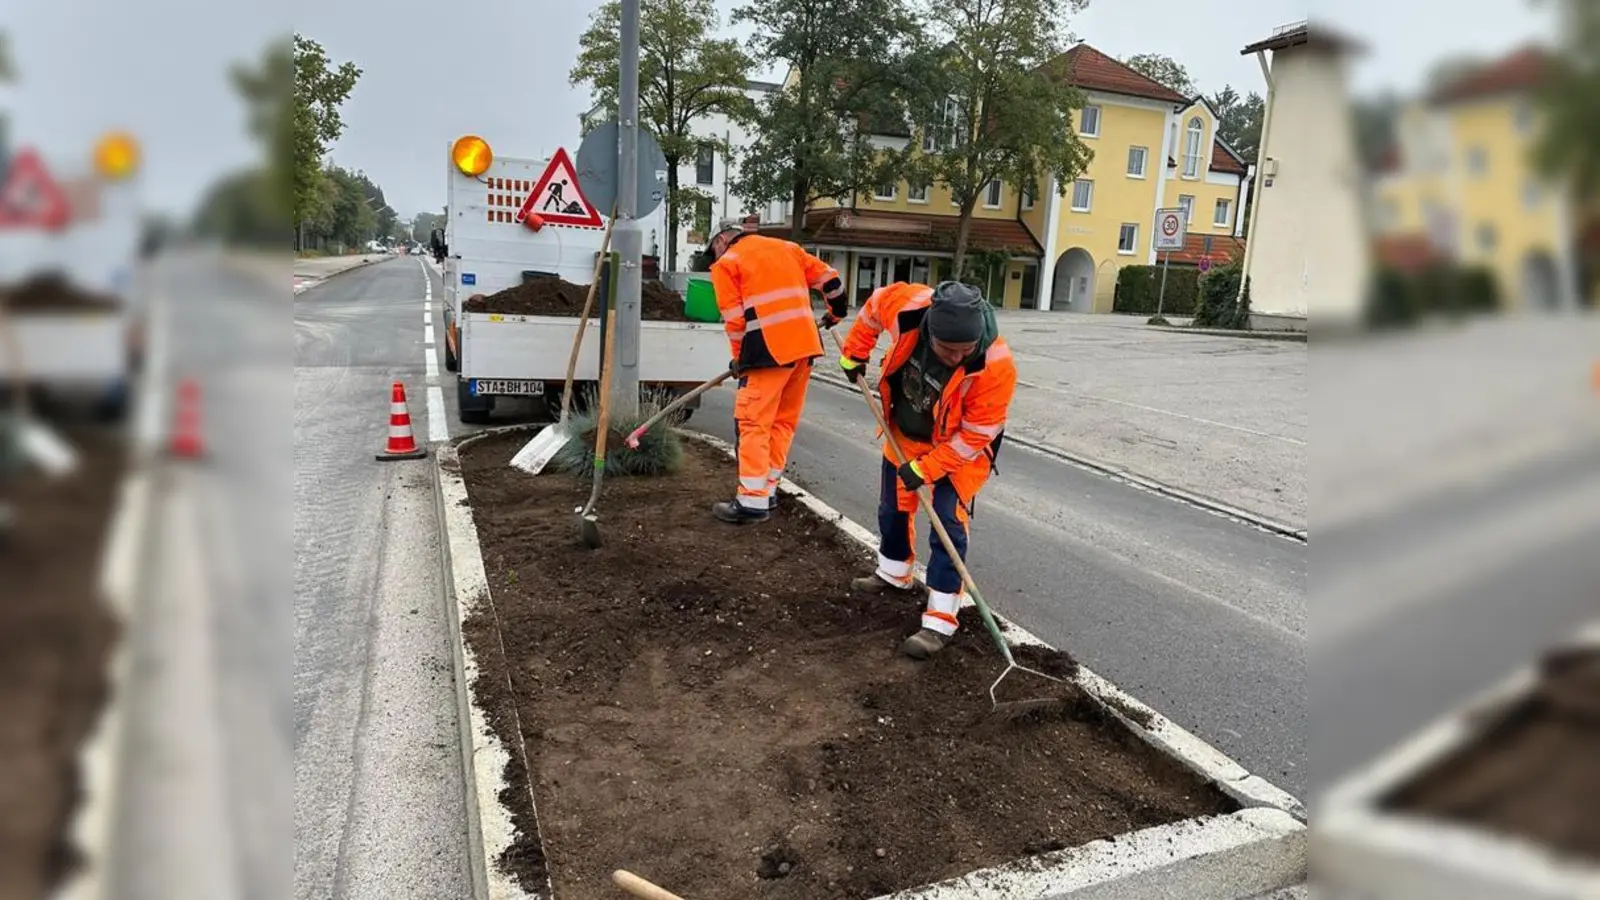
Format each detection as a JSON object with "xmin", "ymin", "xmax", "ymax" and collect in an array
[{"xmin": 762, "ymin": 208, "xmax": 1043, "ymax": 256}]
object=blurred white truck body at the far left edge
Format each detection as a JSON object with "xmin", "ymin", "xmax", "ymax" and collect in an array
[{"xmin": 0, "ymin": 152, "xmax": 141, "ymax": 388}]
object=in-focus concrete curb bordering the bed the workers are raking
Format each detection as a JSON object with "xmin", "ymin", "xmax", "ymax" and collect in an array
[{"xmin": 435, "ymin": 426, "xmax": 1307, "ymax": 900}]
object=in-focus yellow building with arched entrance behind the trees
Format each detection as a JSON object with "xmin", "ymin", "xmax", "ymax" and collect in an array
[{"xmin": 763, "ymin": 45, "xmax": 1248, "ymax": 312}]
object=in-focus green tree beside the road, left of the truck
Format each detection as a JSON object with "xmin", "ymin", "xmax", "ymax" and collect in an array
[{"xmin": 288, "ymin": 32, "xmax": 362, "ymax": 224}]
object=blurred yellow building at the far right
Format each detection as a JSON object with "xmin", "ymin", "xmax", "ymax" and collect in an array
[{"xmin": 1371, "ymin": 48, "xmax": 1579, "ymax": 309}]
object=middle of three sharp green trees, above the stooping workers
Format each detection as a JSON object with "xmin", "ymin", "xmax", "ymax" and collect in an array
[{"xmin": 734, "ymin": 0, "xmax": 934, "ymax": 237}]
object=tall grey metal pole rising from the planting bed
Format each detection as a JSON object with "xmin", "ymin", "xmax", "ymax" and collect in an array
[{"xmin": 611, "ymin": 0, "xmax": 645, "ymax": 416}]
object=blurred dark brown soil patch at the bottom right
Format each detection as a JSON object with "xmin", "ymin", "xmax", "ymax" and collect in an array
[{"xmin": 1386, "ymin": 649, "xmax": 1600, "ymax": 863}]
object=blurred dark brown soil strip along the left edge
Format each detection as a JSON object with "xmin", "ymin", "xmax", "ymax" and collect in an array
[{"xmin": 0, "ymin": 432, "xmax": 123, "ymax": 898}]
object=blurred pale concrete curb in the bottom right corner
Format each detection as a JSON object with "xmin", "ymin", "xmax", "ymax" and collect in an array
[{"xmin": 1310, "ymin": 621, "xmax": 1600, "ymax": 900}]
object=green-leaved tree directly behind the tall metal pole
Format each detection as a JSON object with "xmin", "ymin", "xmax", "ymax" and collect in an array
[{"xmin": 570, "ymin": 0, "xmax": 752, "ymax": 271}]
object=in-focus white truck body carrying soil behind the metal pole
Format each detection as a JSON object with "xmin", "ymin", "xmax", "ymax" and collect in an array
[{"xmin": 443, "ymin": 145, "xmax": 728, "ymax": 418}]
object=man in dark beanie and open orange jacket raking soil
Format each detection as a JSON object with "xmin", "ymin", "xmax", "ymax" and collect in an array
[{"xmin": 838, "ymin": 282, "xmax": 1016, "ymax": 660}]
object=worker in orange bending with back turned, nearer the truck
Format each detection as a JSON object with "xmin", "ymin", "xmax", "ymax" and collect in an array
[{"xmin": 709, "ymin": 220, "xmax": 848, "ymax": 524}]
